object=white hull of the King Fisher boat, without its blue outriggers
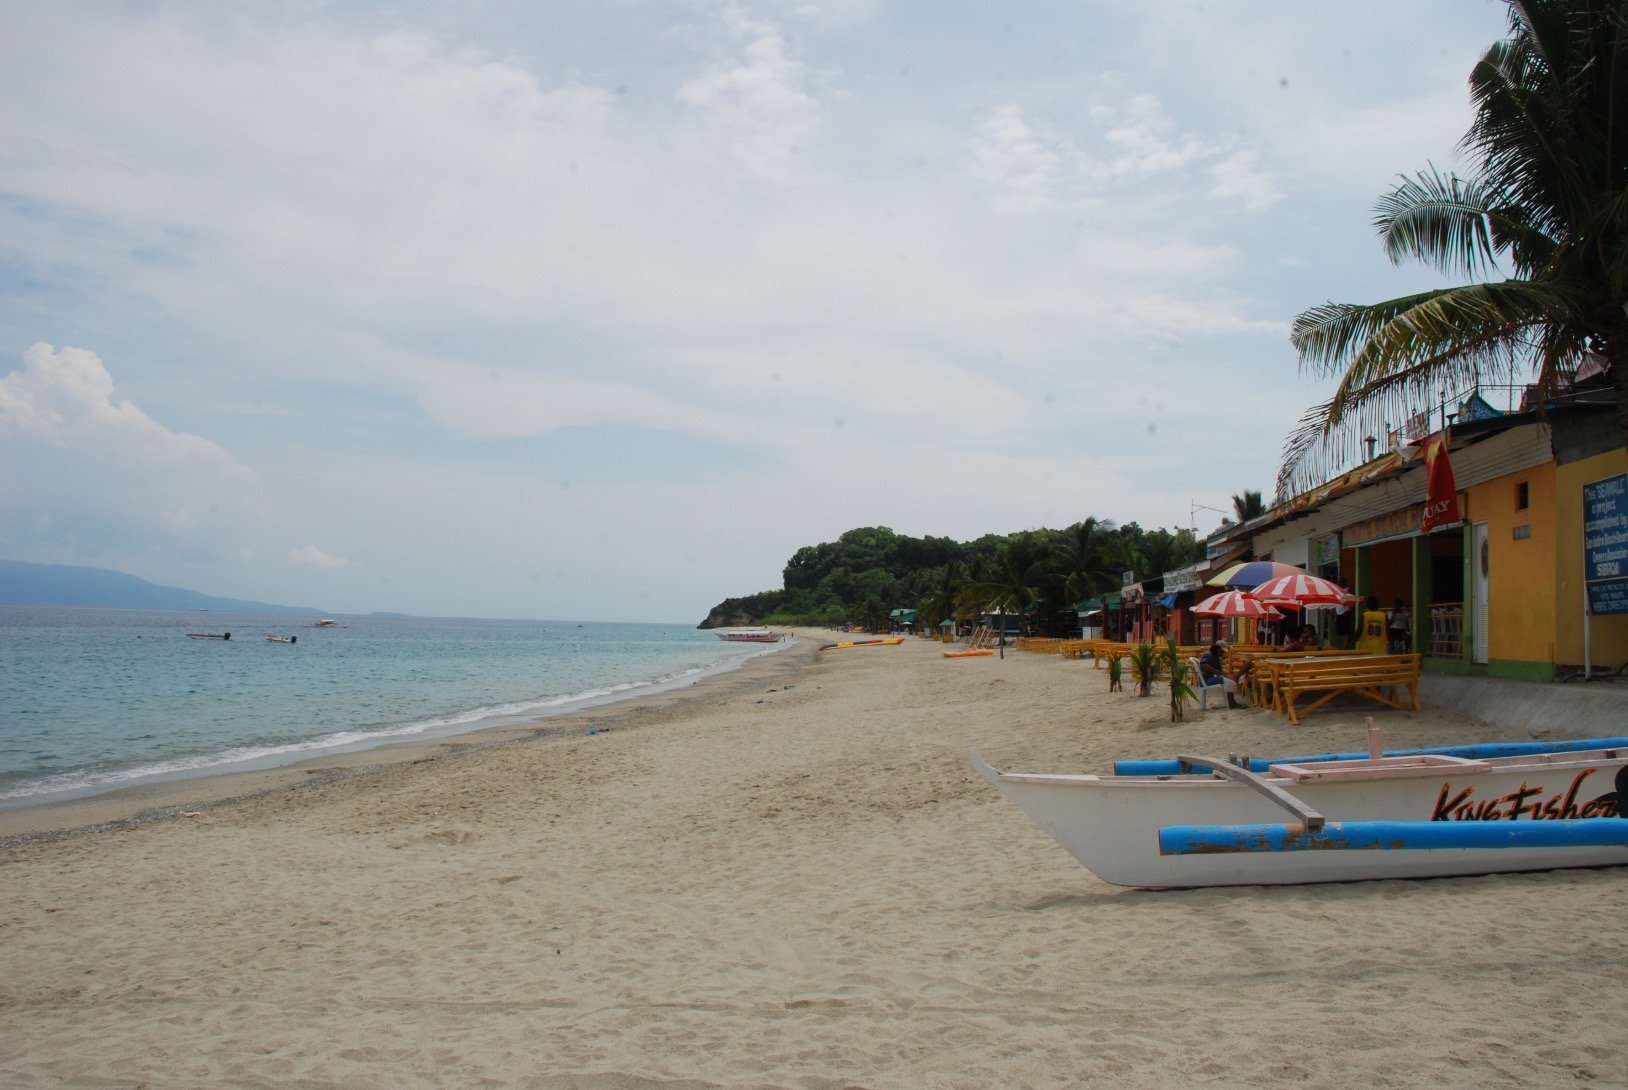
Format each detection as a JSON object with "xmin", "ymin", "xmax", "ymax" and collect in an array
[{"xmin": 972, "ymin": 750, "xmax": 1628, "ymax": 888}]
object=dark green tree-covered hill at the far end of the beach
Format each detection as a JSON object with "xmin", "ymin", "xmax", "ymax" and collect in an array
[{"xmin": 700, "ymin": 519, "xmax": 1203, "ymax": 631}]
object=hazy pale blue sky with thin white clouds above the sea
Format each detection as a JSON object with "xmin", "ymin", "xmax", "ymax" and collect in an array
[{"xmin": 0, "ymin": 0, "xmax": 1506, "ymax": 623}]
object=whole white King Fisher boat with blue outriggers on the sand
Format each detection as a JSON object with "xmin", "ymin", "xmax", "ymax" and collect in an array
[{"xmin": 972, "ymin": 727, "xmax": 1628, "ymax": 888}]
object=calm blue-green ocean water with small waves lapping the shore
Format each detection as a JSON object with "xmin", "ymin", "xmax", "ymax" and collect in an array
[{"xmin": 0, "ymin": 605, "xmax": 783, "ymax": 807}]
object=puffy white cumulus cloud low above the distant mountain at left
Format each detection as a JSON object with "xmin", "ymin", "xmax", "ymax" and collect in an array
[{"xmin": 0, "ymin": 343, "xmax": 259, "ymax": 558}]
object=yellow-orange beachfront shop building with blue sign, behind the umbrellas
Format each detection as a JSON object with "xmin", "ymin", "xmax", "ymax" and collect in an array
[{"xmin": 1206, "ymin": 399, "xmax": 1628, "ymax": 680}]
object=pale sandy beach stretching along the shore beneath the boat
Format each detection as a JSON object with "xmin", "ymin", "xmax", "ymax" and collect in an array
[{"xmin": 0, "ymin": 633, "xmax": 1628, "ymax": 1090}]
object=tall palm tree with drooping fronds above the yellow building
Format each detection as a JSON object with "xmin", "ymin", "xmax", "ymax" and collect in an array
[{"xmin": 1278, "ymin": 0, "xmax": 1628, "ymax": 496}]
